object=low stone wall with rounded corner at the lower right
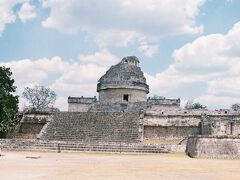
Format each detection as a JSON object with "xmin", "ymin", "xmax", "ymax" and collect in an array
[{"xmin": 186, "ymin": 135, "xmax": 240, "ymax": 159}]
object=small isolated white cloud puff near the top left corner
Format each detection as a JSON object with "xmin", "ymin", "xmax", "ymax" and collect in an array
[{"xmin": 18, "ymin": 2, "xmax": 37, "ymax": 23}]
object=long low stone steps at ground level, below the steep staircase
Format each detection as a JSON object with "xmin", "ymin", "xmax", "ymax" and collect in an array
[{"xmin": 0, "ymin": 140, "xmax": 172, "ymax": 153}]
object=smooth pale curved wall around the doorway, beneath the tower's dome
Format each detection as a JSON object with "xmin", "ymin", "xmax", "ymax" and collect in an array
[{"xmin": 99, "ymin": 88, "xmax": 147, "ymax": 103}]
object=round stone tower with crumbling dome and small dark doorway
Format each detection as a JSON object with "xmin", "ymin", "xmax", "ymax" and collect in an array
[{"xmin": 97, "ymin": 56, "xmax": 149, "ymax": 103}]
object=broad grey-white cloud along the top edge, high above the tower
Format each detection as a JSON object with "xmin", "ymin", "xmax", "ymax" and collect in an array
[{"xmin": 42, "ymin": 0, "xmax": 205, "ymax": 49}]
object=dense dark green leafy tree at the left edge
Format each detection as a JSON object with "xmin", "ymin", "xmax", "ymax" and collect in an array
[{"xmin": 0, "ymin": 67, "xmax": 18, "ymax": 138}]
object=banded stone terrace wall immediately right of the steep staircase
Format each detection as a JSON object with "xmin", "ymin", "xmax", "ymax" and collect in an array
[{"xmin": 143, "ymin": 112, "xmax": 201, "ymax": 141}]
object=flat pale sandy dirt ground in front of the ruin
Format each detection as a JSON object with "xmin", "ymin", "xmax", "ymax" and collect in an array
[{"xmin": 0, "ymin": 152, "xmax": 240, "ymax": 180}]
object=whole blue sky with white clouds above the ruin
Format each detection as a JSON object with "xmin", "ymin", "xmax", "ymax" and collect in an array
[{"xmin": 0, "ymin": 0, "xmax": 240, "ymax": 110}]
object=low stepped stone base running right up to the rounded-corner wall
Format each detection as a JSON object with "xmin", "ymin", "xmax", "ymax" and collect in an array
[{"xmin": 0, "ymin": 139, "xmax": 185, "ymax": 153}]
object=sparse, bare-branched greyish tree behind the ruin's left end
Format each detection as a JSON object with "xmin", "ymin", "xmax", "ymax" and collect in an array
[{"xmin": 22, "ymin": 86, "xmax": 56, "ymax": 110}]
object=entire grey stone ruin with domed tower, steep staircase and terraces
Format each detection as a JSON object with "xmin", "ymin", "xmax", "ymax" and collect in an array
[{"xmin": 1, "ymin": 56, "xmax": 240, "ymax": 158}]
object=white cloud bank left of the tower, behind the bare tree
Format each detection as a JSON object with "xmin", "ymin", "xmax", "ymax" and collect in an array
[{"xmin": 0, "ymin": 49, "xmax": 117, "ymax": 110}]
